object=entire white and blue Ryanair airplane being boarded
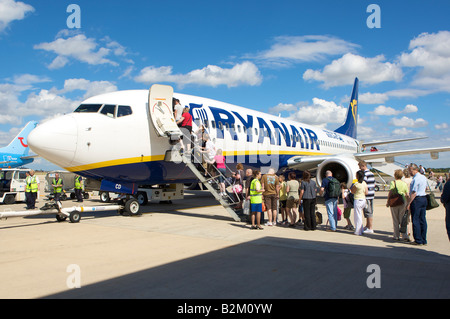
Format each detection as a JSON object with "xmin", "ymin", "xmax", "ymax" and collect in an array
[{"xmin": 28, "ymin": 78, "xmax": 450, "ymax": 218}]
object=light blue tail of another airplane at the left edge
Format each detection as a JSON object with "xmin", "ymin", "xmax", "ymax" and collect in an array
[{"xmin": 0, "ymin": 121, "xmax": 38, "ymax": 168}]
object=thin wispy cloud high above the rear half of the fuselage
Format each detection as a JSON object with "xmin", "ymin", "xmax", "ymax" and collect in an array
[{"xmin": 247, "ymin": 35, "xmax": 358, "ymax": 66}]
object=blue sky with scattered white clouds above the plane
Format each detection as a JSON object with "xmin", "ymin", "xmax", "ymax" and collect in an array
[{"xmin": 0, "ymin": 0, "xmax": 450, "ymax": 168}]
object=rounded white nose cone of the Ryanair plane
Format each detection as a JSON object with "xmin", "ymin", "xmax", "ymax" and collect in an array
[{"xmin": 28, "ymin": 115, "xmax": 78, "ymax": 168}]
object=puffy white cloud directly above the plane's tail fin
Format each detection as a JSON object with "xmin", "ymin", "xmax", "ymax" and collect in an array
[{"xmin": 303, "ymin": 53, "xmax": 403, "ymax": 88}]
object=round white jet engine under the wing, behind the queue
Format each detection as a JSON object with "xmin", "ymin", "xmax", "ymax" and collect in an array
[{"xmin": 316, "ymin": 157, "xmax": 359, "ymax": 187}]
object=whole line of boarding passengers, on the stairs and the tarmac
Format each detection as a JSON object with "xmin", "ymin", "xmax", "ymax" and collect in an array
[{"xmin": 173, "ymin": 104, "xmax": 442, "ymax": 245}]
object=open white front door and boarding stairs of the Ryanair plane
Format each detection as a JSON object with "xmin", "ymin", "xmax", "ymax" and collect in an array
[{"xmin": 148, "ymin": 84, "xmax": 242, "ymax": 221}]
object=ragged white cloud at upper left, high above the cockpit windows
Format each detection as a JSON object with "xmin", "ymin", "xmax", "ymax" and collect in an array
[{"xmin": 34, "ymin": 30, "xmax": 124, "ymax": 69}]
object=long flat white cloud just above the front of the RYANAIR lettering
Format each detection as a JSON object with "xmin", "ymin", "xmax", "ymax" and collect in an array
[{"xmin": 134, "ymin": 61, "xmax": 262, "ymax": 87}]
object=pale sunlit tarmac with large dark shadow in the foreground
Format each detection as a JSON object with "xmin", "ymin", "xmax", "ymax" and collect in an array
[{"xmin": 0, "ymin": 191, "xmax": 450, "ymax": 300}]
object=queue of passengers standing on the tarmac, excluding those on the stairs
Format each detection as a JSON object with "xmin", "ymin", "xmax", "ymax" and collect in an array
[{"xmin": 240, "ymin": 162, "xmax": 442, "ymax": 245}]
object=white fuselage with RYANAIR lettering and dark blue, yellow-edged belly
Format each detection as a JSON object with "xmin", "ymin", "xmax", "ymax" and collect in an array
[{"xmin": 28, "ymin": 90, "xmax": 358, "ymax": 185}]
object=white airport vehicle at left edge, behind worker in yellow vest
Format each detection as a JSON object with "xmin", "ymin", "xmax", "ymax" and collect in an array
[{"xmin": 0, "ymin": 168, "xmax": 33, "ymax": 205}]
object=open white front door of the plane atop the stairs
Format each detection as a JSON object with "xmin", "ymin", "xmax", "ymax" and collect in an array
[{"xmin": 148, "ymin": 84, "xmax": 181, "ymax": 140}]
